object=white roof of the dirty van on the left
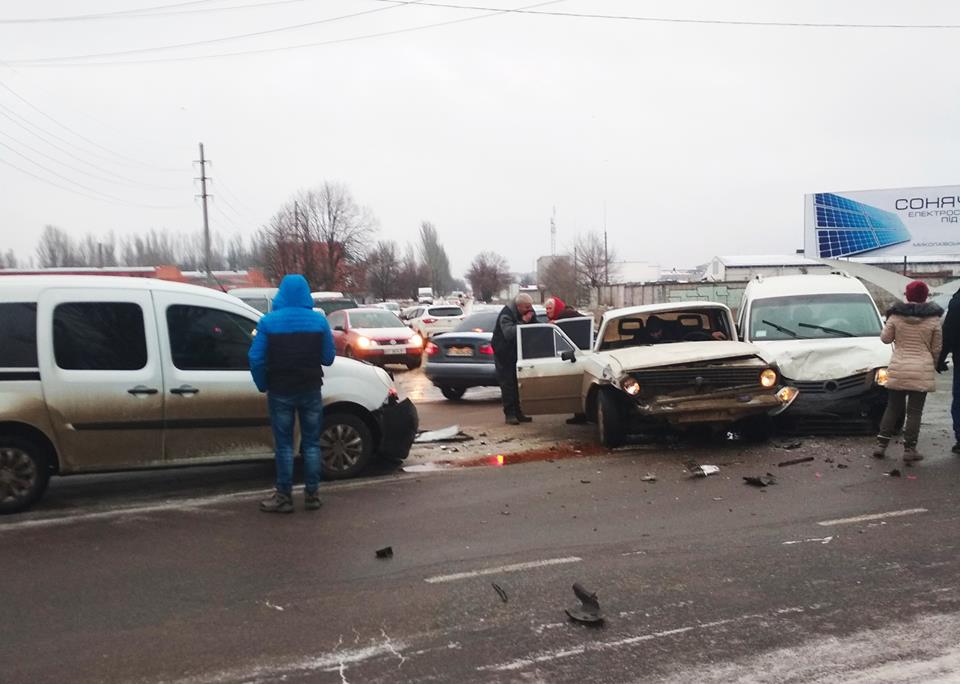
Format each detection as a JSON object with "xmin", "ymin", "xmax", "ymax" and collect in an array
[{"xmin": 0, "ymin": 275, "xmax": 246, "ymax": 306}]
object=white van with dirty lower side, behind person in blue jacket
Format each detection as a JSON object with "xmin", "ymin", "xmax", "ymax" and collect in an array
[{"xmin": 0, "ymin": 275, "xmax": 417, "ymax": 512}]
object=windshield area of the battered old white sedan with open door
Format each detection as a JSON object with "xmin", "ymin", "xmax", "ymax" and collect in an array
[{"xmin": 599, "ymin": 308, "xmax": 733, "ymax": 351}]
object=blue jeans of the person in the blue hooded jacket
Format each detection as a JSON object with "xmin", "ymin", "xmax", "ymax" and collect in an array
[{"xmin": 267, "ymin": 390, "xmax": 323, "ymax": 496}]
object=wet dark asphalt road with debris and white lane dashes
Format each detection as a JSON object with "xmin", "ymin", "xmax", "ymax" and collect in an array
[{"xmin": 0, "ymin": 372, "xmax": 960, "ymax": 683}]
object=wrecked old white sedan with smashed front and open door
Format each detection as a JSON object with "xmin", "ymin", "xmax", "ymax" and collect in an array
[{"xmin": 517, "ymin": 302, "xmax": 798, "ymax": 447}]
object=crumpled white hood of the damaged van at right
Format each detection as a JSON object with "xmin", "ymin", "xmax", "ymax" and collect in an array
[{"xmin": 755, "ymin": 337, "xmax": 891, "ymax": 382}]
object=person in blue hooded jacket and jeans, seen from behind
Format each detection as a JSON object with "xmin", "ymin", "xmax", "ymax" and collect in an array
[{"xmin": 249, "ymin": 275, "xmax": 336, "ymax": 513}]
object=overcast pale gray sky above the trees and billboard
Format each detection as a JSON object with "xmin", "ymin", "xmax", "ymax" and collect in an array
[{"xmin": 0, "ymin": 0, "xmax": 960, "ymax": 276}]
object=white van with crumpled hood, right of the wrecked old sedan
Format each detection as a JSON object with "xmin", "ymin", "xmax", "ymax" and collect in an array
[{"xmin": 738, "ymin": 273, "xmax": 891, "ymax": 430}]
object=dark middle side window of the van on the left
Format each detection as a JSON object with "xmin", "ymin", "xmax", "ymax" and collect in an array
[{"xmin": 53, "ymin": 302, "xmax": 147, "ymax": 370}]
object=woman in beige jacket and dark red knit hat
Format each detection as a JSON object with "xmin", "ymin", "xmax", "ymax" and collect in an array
[{"xmin": 873, "ymin": 280, "xmax": 943, "ymax": 463}]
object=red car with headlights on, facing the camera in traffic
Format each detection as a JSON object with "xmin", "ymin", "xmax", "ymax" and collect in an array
[{"xmin": 327, "ymin": 308, "xmax": 423, "ymax": 370}]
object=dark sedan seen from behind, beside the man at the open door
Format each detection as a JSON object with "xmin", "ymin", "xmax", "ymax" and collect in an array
[{"xmin": 424, "ymin": 309, "xmax": 500, "ymax": 401}]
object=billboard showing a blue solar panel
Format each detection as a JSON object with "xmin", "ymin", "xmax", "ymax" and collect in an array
[{"xmin": 803, "ymin": 185, "xmax": 960, "ymax": 259}]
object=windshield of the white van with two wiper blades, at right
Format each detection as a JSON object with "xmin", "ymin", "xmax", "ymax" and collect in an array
[{"xmin": 750, "ymin": 293, "xmax": 881, "ymax": 342}]
